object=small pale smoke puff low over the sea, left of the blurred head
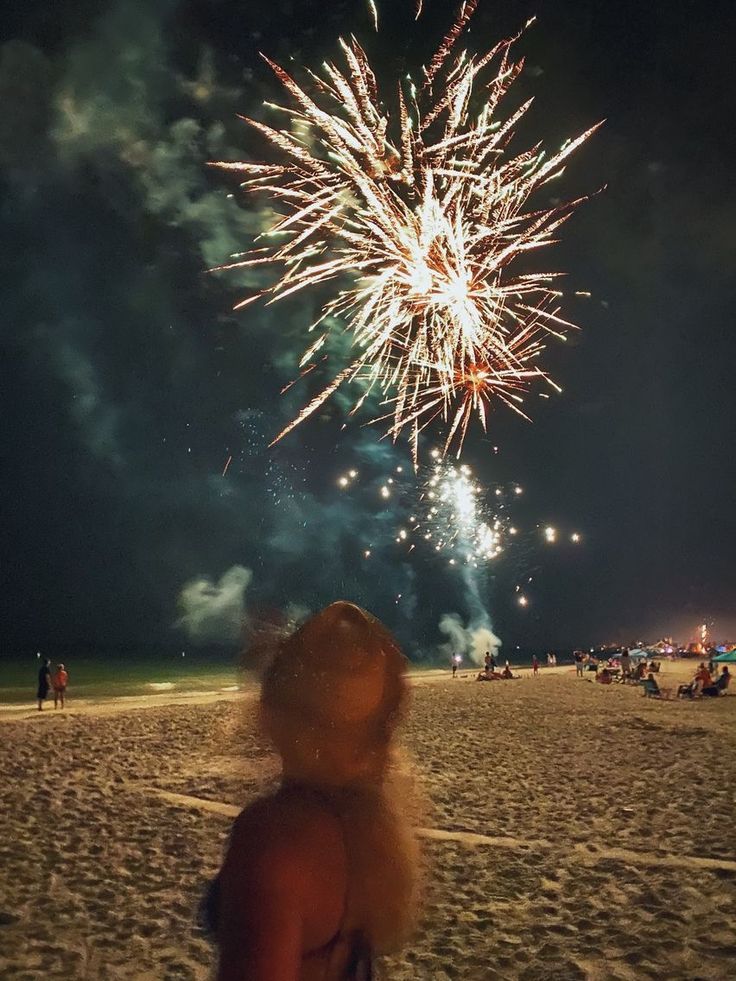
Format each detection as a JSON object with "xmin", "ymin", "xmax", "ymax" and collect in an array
[{"xmin": 176, "ymin": 565, "xmax": 253, "ymax": 644}]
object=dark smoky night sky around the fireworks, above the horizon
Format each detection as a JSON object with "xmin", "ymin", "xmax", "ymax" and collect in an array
[{"xmin": 0, "ymin": 0, "xmax": 736, "ymax": 656}]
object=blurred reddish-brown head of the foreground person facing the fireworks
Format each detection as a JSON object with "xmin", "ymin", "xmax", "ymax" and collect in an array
[{"xmin": 261, "ymin": 601, "xmax": 406, "ymax": 786}]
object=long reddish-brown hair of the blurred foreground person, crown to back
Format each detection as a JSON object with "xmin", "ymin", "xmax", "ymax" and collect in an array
[{"xmin": 261, "ymin": 603, "xmax": 419, "ymax": 953}]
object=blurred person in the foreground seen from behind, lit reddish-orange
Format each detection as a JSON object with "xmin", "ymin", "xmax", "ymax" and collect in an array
[{"xmin": 209, "ymin": 602, "xmax": 418, "ymax": 981}]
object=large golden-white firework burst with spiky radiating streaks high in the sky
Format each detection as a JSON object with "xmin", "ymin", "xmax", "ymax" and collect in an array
[{"xmin": 215, "ymin": 0, "xmax": 597, "ymax": 462}]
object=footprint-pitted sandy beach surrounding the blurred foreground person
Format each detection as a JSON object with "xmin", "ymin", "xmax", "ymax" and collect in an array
[{"xmin": 0, "ymin": 662, "xmax": 736, "ymax": 981}]
